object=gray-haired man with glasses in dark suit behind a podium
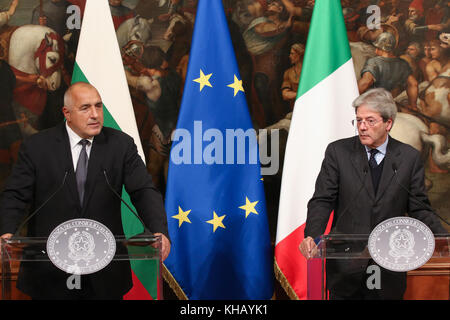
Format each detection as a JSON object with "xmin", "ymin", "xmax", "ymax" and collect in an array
[{"xmin": 300, "ymin": 88, "xmax": 447, "ymax": 299}]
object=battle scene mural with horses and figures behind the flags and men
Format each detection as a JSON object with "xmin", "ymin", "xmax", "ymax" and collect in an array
[{"xmin": 0, "ymin": 0, "xmax": 450, "ymax": 250}]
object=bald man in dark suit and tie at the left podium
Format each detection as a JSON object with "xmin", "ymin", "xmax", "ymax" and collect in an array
[{"xmin": 0, "ymin": 82, "xmax": 170, "ymax": 299}]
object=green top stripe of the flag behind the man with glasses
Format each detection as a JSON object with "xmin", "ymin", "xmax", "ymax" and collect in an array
[{"xmin": 297, "ymin": 0, "xmax": 351, "ymax": 99}]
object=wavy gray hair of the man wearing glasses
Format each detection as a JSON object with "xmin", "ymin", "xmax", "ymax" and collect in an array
[{"xmin": 352, "ymin": 88, "xmax": 397, "ymax": 122}]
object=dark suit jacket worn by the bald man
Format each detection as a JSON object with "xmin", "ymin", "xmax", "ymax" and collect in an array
[{"xmin": 0, "ymin": 123, "xmax": 168, "ymax": 297}]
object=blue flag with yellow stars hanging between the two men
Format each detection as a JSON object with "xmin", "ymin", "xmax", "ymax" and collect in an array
[{"xmin": 165, "ymin": 0, "xmax": 273, "ymax": 299}]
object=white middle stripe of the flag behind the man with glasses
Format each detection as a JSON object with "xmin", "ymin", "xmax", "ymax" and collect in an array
[{"xmin": 276, "ymin": 59, "xmax": 358, "ymax": 244}]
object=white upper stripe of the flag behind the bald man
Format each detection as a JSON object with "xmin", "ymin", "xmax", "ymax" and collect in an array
[{"xmin": 76, "ymin": 0, "xmax": 145, "ymax": 161}]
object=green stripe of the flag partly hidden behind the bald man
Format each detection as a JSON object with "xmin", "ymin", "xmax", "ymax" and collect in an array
[{"xmin": 72, "ymin": 62, "xmax": 159, "ymax": 299}]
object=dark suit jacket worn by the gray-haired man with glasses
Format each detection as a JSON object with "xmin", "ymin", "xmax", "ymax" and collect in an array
[{"xmin": 305, "ymin": 136, "xmax": 447, "ymax": 298}]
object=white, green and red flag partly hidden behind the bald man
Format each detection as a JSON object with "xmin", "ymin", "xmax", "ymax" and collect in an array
[{"xmin": 72, "ymin": 0, "xmax": 159, "ymax": 299}]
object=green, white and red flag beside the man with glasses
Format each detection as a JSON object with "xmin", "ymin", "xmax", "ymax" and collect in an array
[{"xmin": 275, "ymin": 0, "xmax": 358, "ymax": 299}]
